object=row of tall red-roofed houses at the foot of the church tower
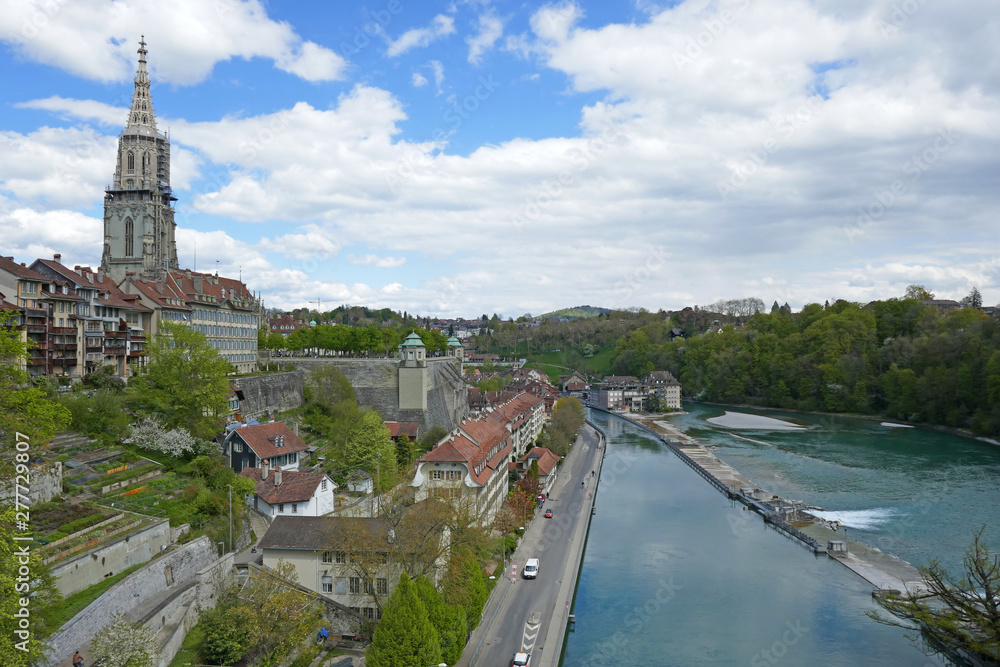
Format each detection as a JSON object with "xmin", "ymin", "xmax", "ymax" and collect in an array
[{"xmin": 0, "ymin": 254, "xmax": 261, "ymax": 378}]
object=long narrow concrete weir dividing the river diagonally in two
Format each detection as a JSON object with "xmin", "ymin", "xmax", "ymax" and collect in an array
[{"xmin": 615, "ymin": 413, "xmax": 927, "ymax": 593}]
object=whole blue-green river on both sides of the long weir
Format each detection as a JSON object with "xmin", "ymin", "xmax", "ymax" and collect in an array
[{"xmin": 563, "ymin": 406, "xmax": 1000, "ymax": 667}]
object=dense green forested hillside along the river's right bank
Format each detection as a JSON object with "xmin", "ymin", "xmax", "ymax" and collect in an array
[{"xmin": 613, "ymin": 299, "xmax": 1000, "ymax": 435}]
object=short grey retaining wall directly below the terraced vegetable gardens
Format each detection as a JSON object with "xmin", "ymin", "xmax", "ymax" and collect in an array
[{"xmin": 52, "ymin": 519, "xmax": 171, "ymax": 596}]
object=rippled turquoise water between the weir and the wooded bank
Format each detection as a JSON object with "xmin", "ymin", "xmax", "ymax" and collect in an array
[{"xmin": 671, "ymin": 404, "xmax": 1000, "ymax": 572}]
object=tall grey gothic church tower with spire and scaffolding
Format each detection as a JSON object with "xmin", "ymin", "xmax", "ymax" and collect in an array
[{"xmin": 101, "ymin": 38, "xmax": 178, "ymax": 283}]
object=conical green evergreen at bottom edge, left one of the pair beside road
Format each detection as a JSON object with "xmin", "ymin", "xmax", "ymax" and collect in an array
[{"xmin": 365, "ymin": 572, "xmax": 441, "ymax": 667}]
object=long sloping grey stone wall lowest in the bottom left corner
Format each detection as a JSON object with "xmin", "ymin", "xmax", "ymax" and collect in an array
[{"xmin": 45, "ymin": 536, "xmax": 219, "ymax": 667}]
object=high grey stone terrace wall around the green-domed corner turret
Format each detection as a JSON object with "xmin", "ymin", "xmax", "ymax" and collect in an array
[{"xmin": 288, "ymin": 357, "xmax": 469, "ymax": 435}]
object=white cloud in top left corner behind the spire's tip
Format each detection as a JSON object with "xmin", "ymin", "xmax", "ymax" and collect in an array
[{"xmin": 0, "ymin": 0, "xmax": 346, "ymax": 85}]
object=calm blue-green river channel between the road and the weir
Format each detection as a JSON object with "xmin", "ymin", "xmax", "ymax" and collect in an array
[{"xmin": 563, "ymin": 411, "xmax": 968, "ymax": 667}]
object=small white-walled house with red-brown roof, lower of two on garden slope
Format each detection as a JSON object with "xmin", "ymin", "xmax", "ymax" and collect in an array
[{"xmin": 240, "ymin": 460, "xmax": 337, "ymax": 517}]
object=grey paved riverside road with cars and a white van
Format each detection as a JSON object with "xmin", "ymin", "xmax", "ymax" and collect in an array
[{"xmin": 458, "ymin": 426, "xmax": 602, "ymax": 667}]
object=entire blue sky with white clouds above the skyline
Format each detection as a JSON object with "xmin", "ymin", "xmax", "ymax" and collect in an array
[{"xmin": 0, "ymin": 0, "xmax": 1000, "ymax": 317}]
